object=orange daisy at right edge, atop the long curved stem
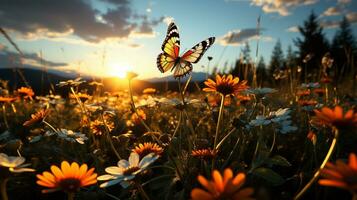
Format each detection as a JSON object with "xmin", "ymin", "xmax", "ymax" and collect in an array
[{"xmin": 313, "ymin": 106, "xmax": 357, "ymax": 129}]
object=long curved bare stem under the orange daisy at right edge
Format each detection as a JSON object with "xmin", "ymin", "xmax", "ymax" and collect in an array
[{"xmin": 294, "ymin": 129, "xmax": 338, "ymax": 200}]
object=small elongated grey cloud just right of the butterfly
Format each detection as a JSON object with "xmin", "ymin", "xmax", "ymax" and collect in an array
[{"xmin": 218, "ymin": 28, "xmax": 273, "ymax": 46}]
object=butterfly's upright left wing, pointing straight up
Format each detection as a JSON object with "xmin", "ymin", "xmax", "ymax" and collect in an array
[{"xmin": 157, "ymin": 23, "xmax": 180, "ymax": 73}]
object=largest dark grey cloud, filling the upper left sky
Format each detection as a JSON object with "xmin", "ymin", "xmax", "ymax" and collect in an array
[{"xmin": 0, "ymin": 0, "xmax": 163, "ymax": 43}]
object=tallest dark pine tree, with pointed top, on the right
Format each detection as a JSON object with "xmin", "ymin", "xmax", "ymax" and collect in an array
[{"xmin": 294, "ymin": 11, "xmax": 329, "ymax": 80}]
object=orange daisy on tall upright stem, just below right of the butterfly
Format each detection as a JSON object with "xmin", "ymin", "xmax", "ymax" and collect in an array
[{"xmin": 203, "ymin": 74, "xmax": 248, "ymax": 96}]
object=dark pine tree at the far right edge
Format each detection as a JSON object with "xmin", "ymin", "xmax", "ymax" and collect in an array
[{"xmin": 332, "ymin": 17, "xmax": 357, "ymax": 77}]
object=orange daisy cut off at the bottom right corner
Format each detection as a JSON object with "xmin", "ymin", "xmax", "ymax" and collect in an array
[{"xmin": 319, "ymin": 153, "xmax": 357, "ymax": 193}]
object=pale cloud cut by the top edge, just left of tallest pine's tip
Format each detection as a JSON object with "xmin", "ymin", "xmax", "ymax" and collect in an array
[{"xmin": 251, "ymin": 0, "xmax": 318, "ymax": 16}]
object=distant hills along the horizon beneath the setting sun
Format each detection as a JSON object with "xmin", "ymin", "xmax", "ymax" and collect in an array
[{"xmin": 0, "ymin": 68, "xmax": 206, "ymax": 95}]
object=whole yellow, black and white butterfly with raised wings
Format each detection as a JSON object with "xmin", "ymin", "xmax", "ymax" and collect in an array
[{"xmin": 156, "ymin": 22, "xmax": 215, "ymax": 78}]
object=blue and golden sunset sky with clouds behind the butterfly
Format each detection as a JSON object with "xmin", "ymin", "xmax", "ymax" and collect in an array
[{"xmin": 0, "ymin": 0, "xmax": 357, "ymax": 79}]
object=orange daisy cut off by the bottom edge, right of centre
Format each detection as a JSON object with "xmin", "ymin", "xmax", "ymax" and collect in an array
[{"xmin": 191, "ymin": 168, "xmax": 254, "ymax": 200}]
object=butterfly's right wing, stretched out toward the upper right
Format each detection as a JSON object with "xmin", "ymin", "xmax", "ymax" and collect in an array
[{"xmin": 181, "ymin": 37, "xmax": 215, "ymax": 63}]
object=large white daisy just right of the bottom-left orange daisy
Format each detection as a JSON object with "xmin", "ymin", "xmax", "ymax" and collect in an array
[{"xmin": 97, "ymin": 152, "xmax": 159, "ymax": 188}]
